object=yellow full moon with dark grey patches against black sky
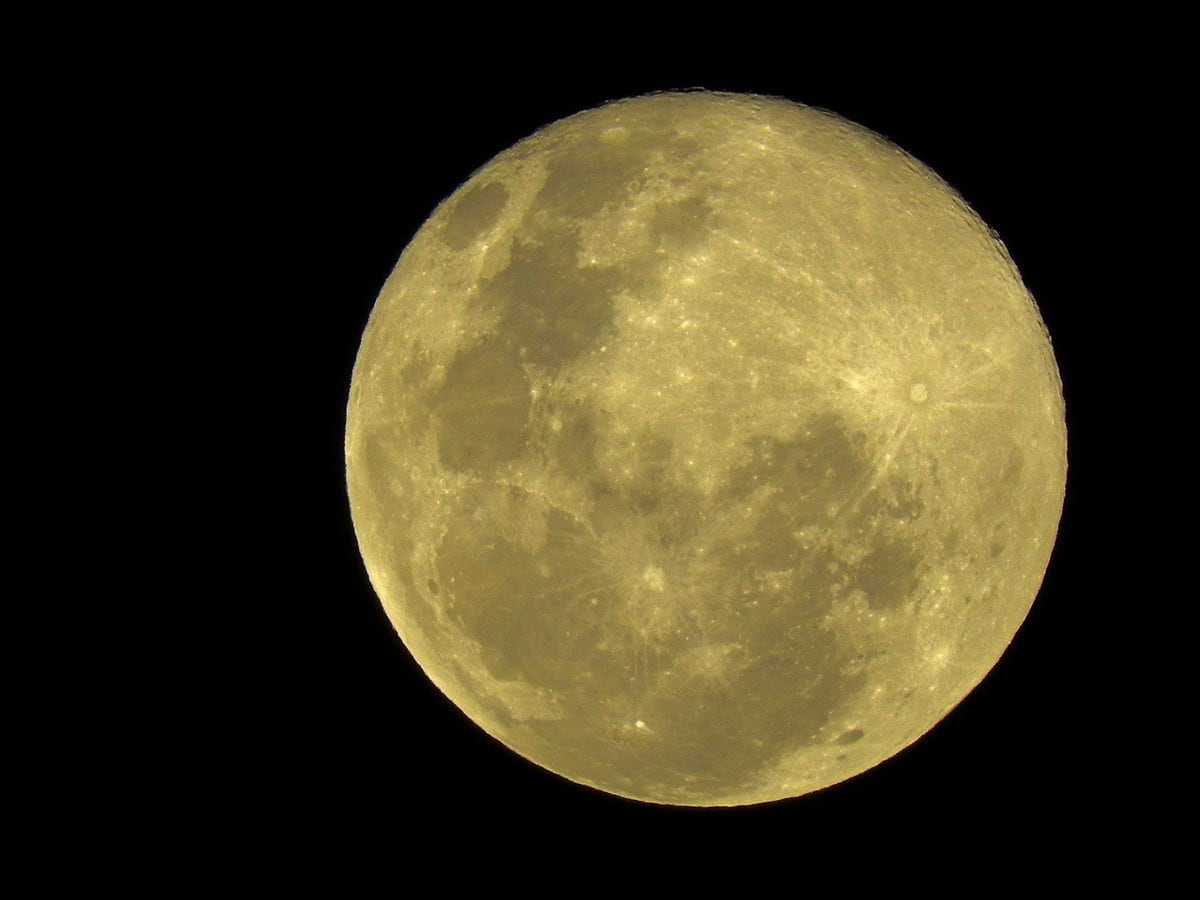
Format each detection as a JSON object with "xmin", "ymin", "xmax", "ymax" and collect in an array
[{"xmin": 346, "ymin": 92, "xmax": 1066, "ymax": 805}]
